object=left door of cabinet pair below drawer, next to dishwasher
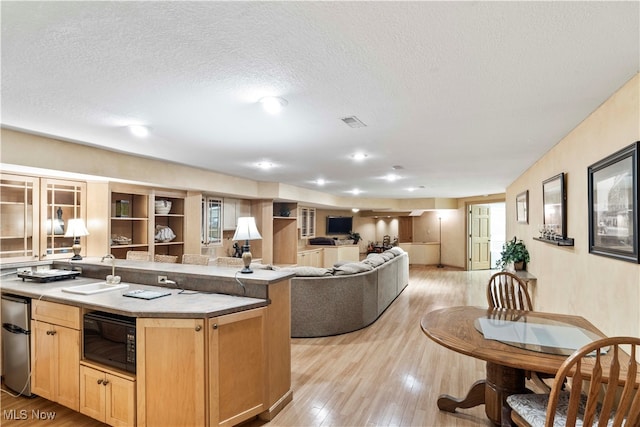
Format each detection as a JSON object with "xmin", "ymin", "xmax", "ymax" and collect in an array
[{"xmin": 31, "ymin": 320, "xmax": 56, "ymax": 401}]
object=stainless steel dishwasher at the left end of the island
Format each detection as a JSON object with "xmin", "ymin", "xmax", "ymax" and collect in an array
[{"xmin": 1, "ymin": 294, "xmax": 31, "ymax": 396}]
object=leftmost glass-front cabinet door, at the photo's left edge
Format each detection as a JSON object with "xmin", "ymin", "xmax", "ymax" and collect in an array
[{"xmin": 0, "ymin": 174, "xmax": 40, "ymax": 261}]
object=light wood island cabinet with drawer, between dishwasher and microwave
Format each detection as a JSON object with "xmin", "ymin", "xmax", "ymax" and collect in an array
[{"xmin": 31, "ymin": 301, "xmax": 80, "ymax": 411}]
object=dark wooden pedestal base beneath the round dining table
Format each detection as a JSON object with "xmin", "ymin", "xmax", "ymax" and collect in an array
[{"xmin": 438, "ymin": 362, "xmax": 527, "ymax": 426}]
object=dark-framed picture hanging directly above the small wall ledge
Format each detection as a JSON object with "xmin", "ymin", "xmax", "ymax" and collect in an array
[{"xmin": 542, "ymin": 172, "xmax": 567, "ymax": 239}]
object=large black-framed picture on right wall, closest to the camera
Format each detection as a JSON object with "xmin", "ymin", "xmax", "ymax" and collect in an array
[{"xmin": 588, "ymin": 141, "xmax": 640, "ymax": 263}]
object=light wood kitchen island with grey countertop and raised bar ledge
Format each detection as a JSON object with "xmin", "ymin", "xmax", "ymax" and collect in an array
[{"xmin": 1, "ymin": 259, "xmax": 292, "ymax": 426}]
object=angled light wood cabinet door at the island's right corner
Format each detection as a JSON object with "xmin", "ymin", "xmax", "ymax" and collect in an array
[{"xmin": 207, "ymin": 308, "xmax": 267, "ymax": 426}]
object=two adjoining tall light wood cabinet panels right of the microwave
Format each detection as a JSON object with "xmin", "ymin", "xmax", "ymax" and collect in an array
[{"xmin": 136, "ymin": 308, "xmax": 267, "ymax": 427}]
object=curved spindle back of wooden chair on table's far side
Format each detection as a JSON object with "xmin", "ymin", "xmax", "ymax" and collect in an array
[{"xmin": 487, "ymin": 271, "xmax": 533, "ymax": 311}]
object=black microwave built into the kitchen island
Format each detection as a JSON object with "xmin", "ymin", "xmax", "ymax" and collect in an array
[{"xmin": 83, "ymin": 311, "xmax": 136, "ymax": 373}]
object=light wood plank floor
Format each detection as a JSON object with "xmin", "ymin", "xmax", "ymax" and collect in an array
[{"xmin": 0, "ymin": 266, "xmax": 500, "ymax": 427}]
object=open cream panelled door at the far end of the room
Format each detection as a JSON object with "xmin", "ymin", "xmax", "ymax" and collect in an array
[{"xmin": 469, "ymin": 205, "xmax": 491, "ymax": 270}]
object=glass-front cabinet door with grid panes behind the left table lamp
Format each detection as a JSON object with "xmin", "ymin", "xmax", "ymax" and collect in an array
[{"xmin": 40, "ymin": 178, "xmax": 91, "ymax": 259}]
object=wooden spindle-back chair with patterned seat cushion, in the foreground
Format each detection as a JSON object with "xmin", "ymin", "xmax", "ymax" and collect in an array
[{"xmin": 507, "ymin": 337, "xmax": 640, "ymax": 427}]
